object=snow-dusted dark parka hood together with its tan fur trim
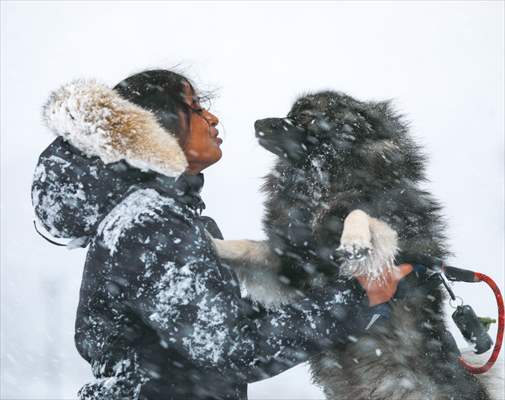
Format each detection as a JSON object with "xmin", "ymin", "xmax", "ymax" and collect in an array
[{"xmin": 32, "ymin": 81, "xmax": 187, "ymax": 239}]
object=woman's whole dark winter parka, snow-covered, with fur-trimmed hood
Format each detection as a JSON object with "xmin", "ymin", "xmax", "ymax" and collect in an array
[{"xmin": 32, "ymin": 81, "xmax": 368, "ymax": 400}]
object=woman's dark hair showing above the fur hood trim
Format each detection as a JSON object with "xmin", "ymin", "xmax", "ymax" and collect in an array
[{"xmin": 114, "ymin": 69, "xmax": 196, "ymax": 145}]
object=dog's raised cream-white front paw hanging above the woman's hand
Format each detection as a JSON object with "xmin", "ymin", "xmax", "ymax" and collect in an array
[{"xmin": 339, "ymin": 210, "xmax": 398, "ymax": 280}]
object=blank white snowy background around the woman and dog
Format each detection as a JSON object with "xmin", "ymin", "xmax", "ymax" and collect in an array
[{"xmin": 0, "ymin": 1, "xmax": 504, "ymax": 399}]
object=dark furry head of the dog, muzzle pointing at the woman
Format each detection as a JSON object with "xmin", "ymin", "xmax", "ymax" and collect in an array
[{"xmin": 255, "ymin": 91, "xmax": 424, "ymax": 180}]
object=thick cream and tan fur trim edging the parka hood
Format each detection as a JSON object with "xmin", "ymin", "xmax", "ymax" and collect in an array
[{"xmin": 42, "ymin": 80, "xmax": 188, "ymax": 177}]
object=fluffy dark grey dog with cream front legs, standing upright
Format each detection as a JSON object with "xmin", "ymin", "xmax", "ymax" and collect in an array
[{"xmin": 216, "ymin": 92, "xmax": 490, "ymax": 400}]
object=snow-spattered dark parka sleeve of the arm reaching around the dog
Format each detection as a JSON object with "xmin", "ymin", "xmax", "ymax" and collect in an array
[{"xmin": 111, "ymin": 209, "xmax": 364, "ymax": 381}]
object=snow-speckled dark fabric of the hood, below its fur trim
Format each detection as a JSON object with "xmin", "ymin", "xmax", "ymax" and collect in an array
[{"xmin": 32, "ymin": 138, "xmax": 154, "ymax": 239}]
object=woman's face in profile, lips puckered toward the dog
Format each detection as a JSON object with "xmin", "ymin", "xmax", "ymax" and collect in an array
[{"xmin": 180, "ymin": 84, "xmax": 223, "ymax": 175}]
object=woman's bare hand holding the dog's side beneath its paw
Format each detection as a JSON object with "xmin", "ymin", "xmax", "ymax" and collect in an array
[{"xmin": 356, "ymin": 264, "xmax": 413, "ymax": 307}]
